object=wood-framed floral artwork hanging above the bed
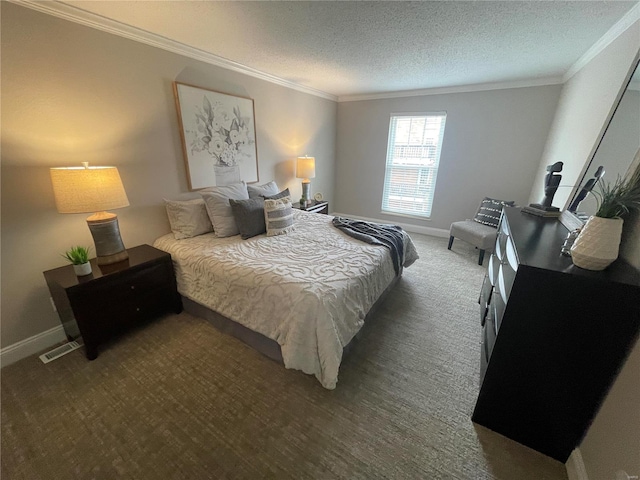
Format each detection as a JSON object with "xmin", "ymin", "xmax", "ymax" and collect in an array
[{"xmin": 173, "ymin": 82, "xmax": 258, "ymax": 190}]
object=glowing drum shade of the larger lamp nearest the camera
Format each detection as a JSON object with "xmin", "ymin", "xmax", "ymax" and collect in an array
[{"xmin": 51, "ymin": 167, "xmax": 129, "ymax": 213}]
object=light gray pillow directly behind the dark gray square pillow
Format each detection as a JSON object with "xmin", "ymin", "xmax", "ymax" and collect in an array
[{"xmin": 201, "ymin": 182, "xmax": 249, "ymax": 238}]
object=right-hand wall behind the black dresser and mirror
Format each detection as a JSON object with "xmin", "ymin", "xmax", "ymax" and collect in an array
[{"xmin": 530, "ymin": 17, "xmax": 640, "ymax": 480}]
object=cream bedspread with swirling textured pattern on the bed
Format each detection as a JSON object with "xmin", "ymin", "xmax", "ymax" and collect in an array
[{"xmin": 154, "ymin": 210, "xmax": 418, "ymax": 389}]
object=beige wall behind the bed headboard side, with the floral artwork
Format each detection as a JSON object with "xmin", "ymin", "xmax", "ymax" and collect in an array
[{"xmin": 0, "ymin": 2, "xmax": 337, "ymax": 347}]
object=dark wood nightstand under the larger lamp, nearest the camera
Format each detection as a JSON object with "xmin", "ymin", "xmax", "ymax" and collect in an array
[{"xmin": 44, "ymin": 245, "xmax": 182, "ymax": 360}]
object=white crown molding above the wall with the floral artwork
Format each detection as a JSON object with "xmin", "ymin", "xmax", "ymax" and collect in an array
[{"xmin": 8, "ymin": 0, "xmax": 338, "ymax": 102}]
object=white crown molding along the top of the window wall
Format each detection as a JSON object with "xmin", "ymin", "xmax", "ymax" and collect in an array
[{"xmin": 338, "ymin": 77, "xmax": 563, "ymax": 102}]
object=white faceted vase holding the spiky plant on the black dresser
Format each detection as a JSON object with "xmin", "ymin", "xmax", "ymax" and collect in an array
[{"xmin": 571, "ymin": 217, "xmax": 623, "ymax": 270}]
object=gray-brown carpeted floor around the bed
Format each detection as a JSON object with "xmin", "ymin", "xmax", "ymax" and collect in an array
[{"xmin": 0, "ymin": 234, "xmax": 566, "ymax": 480}]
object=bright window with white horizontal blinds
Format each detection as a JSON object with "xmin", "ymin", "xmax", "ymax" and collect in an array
[{"xmin": 382, "ymin": 113, "xmax": 447, "ymax": 217}]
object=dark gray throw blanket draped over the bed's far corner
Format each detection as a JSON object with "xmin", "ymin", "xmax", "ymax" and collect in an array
[{"xmin": 333, "ymin": 217, "xmax": 404, "ymax": 275}]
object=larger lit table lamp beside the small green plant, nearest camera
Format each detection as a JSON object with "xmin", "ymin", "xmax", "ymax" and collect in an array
[{"xmin": 50, "ymin": 162, "xmax": 129, "ymax": 265}]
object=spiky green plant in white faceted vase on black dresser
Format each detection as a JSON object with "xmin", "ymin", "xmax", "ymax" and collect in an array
[{"xmin": 571, "ymin": 164, "xmax": 640, "ymax": 270}]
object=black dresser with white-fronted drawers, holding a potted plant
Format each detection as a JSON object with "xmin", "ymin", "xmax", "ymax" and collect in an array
[{"xmin": 472, "ymin": 207, "xmax": 640, "ymax": 462}]
